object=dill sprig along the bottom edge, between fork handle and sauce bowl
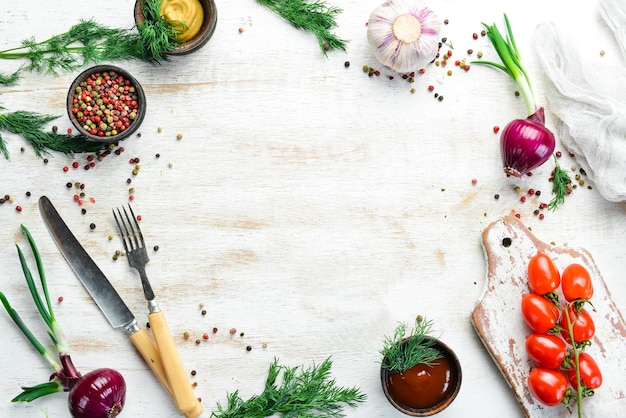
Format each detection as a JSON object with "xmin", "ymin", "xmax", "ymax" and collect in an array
[{"xmin": 211, "ymin": 358, "xmax": 367, "ymax": 418}]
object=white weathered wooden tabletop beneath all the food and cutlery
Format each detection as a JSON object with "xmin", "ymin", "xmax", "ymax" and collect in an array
[{"xmin": 0, "ymin": 0, "xmax": 626, "ymax": 418}]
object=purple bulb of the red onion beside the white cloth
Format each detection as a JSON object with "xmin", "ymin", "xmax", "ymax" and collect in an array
[{"xmin": 500, "ymin": 107, "xmax": 556, "ymax": 178}]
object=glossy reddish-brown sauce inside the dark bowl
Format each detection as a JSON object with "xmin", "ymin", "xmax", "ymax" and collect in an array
[{"xmin": 387, "ymin": 356, "xmax": 458, "ymax": 409}]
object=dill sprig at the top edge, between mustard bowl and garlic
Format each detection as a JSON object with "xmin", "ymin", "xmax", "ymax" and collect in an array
[{"xmin": 257, "ymin": 0, "xmax": 347, "ymax": 55}]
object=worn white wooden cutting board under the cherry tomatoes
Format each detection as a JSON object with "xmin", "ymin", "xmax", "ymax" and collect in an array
[{"xmin": 471, "ymin": 215, "xmax": 626, "ymax": 418}]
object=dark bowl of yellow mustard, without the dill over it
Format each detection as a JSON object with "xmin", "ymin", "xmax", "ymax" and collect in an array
[{"xmin": 135, "ymin": 0, "xmax": 217, "ymax": 55}]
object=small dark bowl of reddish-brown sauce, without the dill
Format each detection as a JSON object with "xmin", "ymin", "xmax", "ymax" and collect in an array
[{"xmin": 380, "ymin": 337, "xmax": 462, "ymax": 417}]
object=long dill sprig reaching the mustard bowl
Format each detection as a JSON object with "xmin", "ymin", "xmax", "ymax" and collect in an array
[{"xmin": 0, "ymin": 0, "xmax": 180, "ymax": 85}]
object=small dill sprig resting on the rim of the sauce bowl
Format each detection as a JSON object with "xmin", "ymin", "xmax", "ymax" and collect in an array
[{"xmin": 380, "ymin": 316, "xmax": 442, "ymax": 373}]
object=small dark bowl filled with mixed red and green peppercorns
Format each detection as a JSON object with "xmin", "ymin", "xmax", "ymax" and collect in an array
[{"xmin": 67, "ymin": 65, "xmax": 146, "ymax": 143}]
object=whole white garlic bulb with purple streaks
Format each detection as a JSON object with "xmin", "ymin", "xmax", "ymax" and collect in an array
[{"xmin": 367, "ymin": 0, "xmax": 441, "ymax": 73}]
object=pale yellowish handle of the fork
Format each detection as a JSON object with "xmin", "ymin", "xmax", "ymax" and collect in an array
[{"xmin": 148, "ymin": 312, "xmax": 202, "ymax": 418}]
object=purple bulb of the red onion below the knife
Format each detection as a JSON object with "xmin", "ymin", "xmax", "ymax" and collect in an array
[{"xmin": 68, "ymin": 369, "xmax": 126, "ymax": 418}]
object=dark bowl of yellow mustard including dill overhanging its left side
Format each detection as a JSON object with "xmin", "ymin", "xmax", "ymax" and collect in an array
[{"xmin": 135, "ymin": 0, "xmax": 217, "ymax": 55}]
